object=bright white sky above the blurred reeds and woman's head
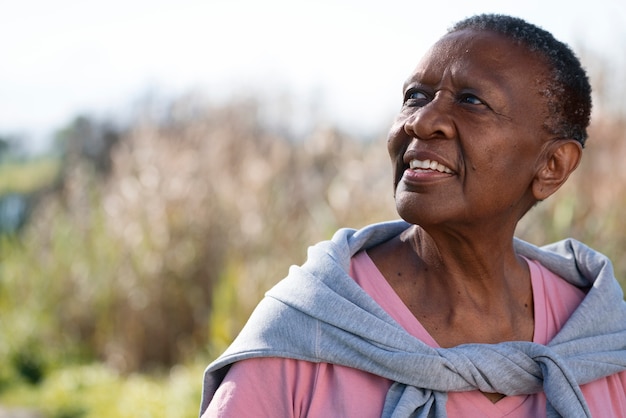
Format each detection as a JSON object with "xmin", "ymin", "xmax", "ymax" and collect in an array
[{"xmin": 0, "ymin": 0, "xmax": 626, "ymax": 150}]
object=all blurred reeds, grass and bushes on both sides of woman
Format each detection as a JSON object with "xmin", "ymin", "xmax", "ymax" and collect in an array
[{"xmin": 0, "ymin": 53, "xmax": 626, "ymax": 418}]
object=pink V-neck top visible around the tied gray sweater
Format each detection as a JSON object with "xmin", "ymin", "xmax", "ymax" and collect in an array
[{"xmin": 203, "ymin": 251, "xmax": 626, "ymax": 418}]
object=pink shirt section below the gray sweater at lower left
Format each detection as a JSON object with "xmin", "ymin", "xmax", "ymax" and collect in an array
[{"xmin": 203, "ymin": 357, "xmax": 391, "ymax": 418}]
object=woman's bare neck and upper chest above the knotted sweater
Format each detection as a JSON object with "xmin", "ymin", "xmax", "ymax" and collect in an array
[{"xmin": 392, "ymin": 226, "xmax": 533, "ymax": 346}]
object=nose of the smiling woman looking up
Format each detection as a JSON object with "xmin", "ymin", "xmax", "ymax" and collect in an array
[{"xmin": 404, "ymin": 91, "xmax": 455, "ymax": 139}]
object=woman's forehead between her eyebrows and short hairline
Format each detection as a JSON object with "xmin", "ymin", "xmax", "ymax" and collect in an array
[{"xmin": 404, "ymin": 29, "xmax": 549, "ymax": 87}]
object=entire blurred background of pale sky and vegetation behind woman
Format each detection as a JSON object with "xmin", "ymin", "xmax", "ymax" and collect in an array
[{"xmin": 0, "ymin": 0, "xmax": 626, "ymax": 418}]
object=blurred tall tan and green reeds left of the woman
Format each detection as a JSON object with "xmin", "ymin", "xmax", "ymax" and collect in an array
[{"xmin": 0, "ymin": 96, "xmax": 392, "ymax": 380}]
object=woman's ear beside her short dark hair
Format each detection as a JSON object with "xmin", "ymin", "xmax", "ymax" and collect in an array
[{"xmin": 532, "ymin": 139, "xmax": 582, "ymax": 201}]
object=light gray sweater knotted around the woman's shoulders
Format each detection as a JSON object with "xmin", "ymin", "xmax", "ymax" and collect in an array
[{"xmin": 201, "ymin": 221, "xmax": 626, "ymax": 418}]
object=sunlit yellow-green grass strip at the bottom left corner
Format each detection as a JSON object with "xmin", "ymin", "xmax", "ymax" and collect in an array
[{"xmin": 0, "ymin": 362, "xmax": 206, "ymax": 418}]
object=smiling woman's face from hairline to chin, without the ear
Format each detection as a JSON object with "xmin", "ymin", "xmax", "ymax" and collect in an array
[{"xmin": 388, "ymin": 30, "xmax": 549, "ymax": 232}]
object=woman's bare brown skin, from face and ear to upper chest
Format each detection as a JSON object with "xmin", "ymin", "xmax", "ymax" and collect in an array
[{"xmin": 368, "ymin": 30, "xmax": 582, "ymax": 402}]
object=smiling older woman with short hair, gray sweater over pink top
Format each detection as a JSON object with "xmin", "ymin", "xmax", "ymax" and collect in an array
[{"xmin": 201, "ymin": 15, "xmax": 626, "ymax": 418}]
